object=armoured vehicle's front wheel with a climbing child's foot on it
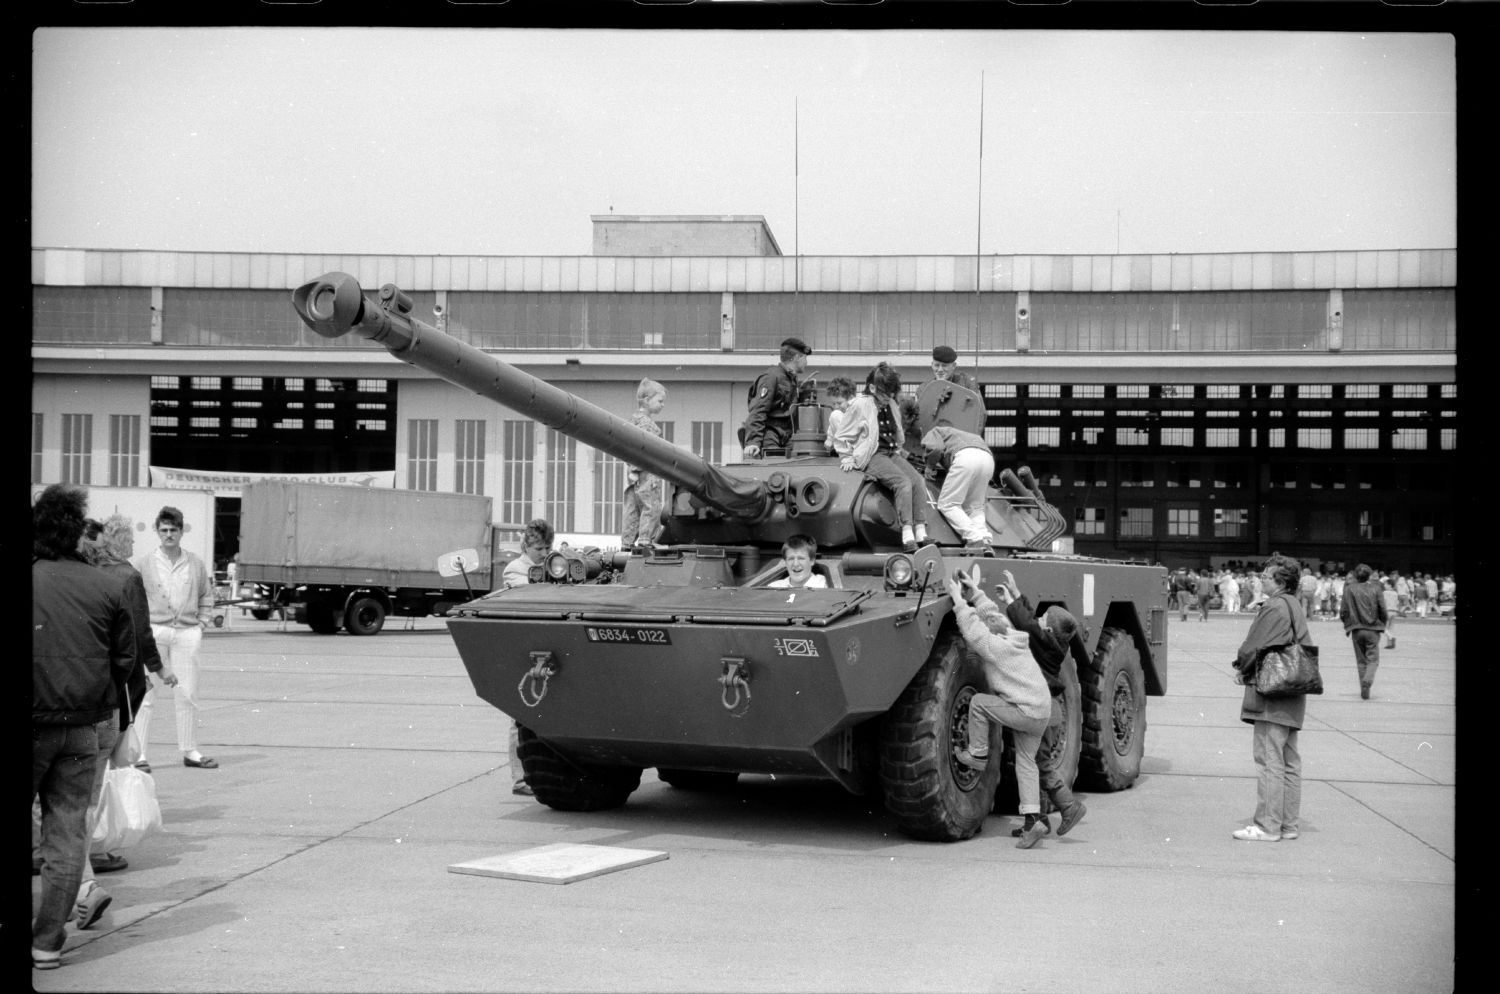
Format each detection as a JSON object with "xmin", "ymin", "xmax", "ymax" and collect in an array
[{"xmin": 881, "ymin": 630, "xmax": 1001, "ymax": 843}]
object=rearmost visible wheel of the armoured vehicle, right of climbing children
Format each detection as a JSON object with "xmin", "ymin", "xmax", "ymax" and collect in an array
[{"xmin": 1079, "ymin": 628, "xmax": 1146, "ymax": 792}]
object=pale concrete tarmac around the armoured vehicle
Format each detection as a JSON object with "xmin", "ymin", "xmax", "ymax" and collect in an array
[{"xmin": 32, "ymin": 615, "xmax": 1457, "ymax": 994}]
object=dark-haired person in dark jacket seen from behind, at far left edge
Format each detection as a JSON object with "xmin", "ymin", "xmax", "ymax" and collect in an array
[{"xmin": 32, "ymin": 484, "xmax": 135, "ymax": 970}]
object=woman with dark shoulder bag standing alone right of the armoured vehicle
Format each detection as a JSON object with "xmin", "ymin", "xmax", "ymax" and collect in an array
[{"xmin": 1235, "ymin": 555, "xmax": 1313, "ymax": 843}]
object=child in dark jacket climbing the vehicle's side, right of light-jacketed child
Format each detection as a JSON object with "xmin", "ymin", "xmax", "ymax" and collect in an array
[{"xmin": 996, "ymin": 570, "xmax": 1089, "ymax": 837}]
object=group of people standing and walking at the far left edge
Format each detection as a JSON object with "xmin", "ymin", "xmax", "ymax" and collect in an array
[{"xmin": 32, "ymin": 484, "xmax": 218, "ymax": 970}]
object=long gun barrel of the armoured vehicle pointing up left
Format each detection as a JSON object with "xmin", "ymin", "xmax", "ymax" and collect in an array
[{"xmin": 293, "ymin": 273, "xmax": 773, "ymax": 520}]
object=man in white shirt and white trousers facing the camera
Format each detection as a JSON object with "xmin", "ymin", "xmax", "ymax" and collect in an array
[{"xmin": 135, "ymin": 507, "xmax": 219, "ymax": 769}]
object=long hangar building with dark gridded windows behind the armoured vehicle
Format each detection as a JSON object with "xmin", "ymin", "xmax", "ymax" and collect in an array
[{"xmin": 32, "ymin": 214, "xmax": 1458, "ymax": 573}]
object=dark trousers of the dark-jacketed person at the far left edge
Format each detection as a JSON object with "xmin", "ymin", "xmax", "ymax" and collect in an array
[{"xmin": 32, "ymin": 724, "xmax": 99, "ymax": 952}]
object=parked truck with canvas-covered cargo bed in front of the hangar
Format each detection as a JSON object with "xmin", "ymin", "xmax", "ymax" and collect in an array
[{"xmin": 240, "ymin": 480, "xmax": 506, "ymax": 636}]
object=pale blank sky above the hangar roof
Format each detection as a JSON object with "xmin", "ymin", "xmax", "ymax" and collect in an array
[{"xmin": 32, "ymin": 28, "xmax": 1458, "ymax": 255}]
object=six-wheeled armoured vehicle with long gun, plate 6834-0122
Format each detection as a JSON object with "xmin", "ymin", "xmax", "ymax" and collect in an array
[{"xmin": 293, "ymin": 273, "xmax": 1167, "ymax": 841}]
